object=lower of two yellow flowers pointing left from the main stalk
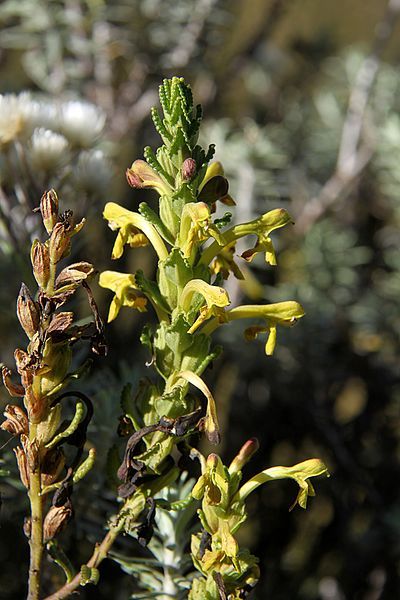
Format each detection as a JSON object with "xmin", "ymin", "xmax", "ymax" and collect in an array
[{"xmin": 99, "ymin": 271, "xmax": 147, "ymax": 323}]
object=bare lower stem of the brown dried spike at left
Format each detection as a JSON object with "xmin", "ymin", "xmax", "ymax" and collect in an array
[{"xmin": 28, "ymin": 424, "xmax": 43, "ymax": 600}]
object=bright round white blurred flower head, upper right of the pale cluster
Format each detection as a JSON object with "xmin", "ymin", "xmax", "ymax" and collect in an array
[{"xmin": 60, "ymin": 100, "xmax": 105, "ymax": 148}]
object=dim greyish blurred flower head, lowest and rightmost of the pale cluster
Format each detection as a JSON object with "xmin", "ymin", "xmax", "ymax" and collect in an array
[{"xmin": 75, "ymin": 150, "xmax": 112, "ymax": 196}]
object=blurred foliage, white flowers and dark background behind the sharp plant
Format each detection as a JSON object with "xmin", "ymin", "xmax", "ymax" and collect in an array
[{"xmin": 0, "ymin": 0, "xmax": 400, "ymax": 600}]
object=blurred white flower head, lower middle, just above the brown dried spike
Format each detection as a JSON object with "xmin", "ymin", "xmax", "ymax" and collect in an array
[{"xmin": 28, "ymin": 127, "xmax": 69, "ymax": 171}]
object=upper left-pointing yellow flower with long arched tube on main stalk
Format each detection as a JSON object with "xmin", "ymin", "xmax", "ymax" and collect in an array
[{"xmin": 103, "ymin": 202, "xmax": 168, "ymax": 260}]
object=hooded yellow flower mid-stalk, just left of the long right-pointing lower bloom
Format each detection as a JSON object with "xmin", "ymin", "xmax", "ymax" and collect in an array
[{"xmin": 179, "ymin": 279, "xmax": 230, "ymax": 333}]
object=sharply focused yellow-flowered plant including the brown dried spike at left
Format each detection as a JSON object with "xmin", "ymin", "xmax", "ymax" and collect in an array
[{"xmin": 2, "ymin": 77, "xmax": 327, "ymax": 600}]
